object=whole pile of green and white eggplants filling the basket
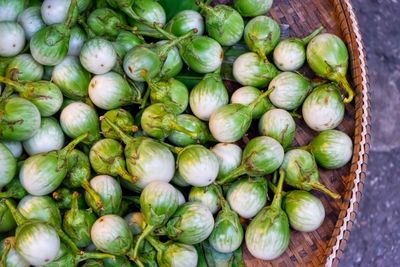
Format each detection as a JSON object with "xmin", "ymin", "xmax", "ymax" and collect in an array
[{"xmin": 0, "ymin": 0, "xmax": 354, "ymax": 267}]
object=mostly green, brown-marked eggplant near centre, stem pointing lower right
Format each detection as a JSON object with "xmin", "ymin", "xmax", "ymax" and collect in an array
[{"xmin": 140, "ymin": 103, "xmax": 198, "ymax": 140}]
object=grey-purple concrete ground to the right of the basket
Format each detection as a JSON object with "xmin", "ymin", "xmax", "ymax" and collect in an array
[{"xmin": 341, "ymin": 0, "xmax": 400, "ymax": 267}]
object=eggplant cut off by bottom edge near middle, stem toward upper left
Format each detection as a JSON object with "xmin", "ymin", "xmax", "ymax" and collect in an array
[{"xmin": 147, "ymin": 237, "xmax": 198, "ymax": 267}]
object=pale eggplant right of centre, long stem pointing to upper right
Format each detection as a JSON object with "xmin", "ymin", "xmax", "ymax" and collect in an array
[{"xmin": 208, "ymin": 90, "xmax": 271, "ymax": 143}]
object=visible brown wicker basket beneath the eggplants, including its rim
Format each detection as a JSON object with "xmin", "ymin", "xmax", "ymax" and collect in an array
[{"xmin": 214, "ymin": 0, "xmax": 370, "ymax": 267}]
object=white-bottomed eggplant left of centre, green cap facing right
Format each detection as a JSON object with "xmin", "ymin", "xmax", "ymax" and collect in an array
[{"xmin": 88, "ymin": 72, "xmax": 140, "ymax": 110}]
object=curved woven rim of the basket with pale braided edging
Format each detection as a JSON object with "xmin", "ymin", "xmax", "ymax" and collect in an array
[{"xmin": 322, "ymin": 0, "xmax": 371, "ymax": 266}]
